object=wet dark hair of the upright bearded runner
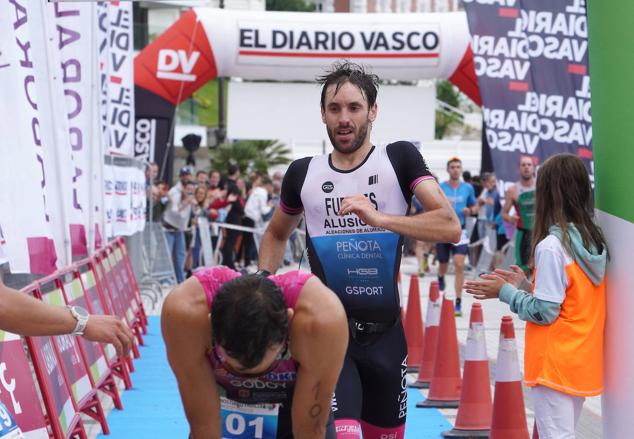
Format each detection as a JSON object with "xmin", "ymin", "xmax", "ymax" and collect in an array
[{"xmin": 317, "ymin": 61, "xmax": 379, "ymax": 110}]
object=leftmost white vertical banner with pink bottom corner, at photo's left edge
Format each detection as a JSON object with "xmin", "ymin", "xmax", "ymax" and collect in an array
[{"xmin": 0, "ymin": 0, "xmax": 63, "ymax": 274}]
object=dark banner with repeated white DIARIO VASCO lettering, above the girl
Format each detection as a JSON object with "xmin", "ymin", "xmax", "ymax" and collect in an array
[{"xmin": 463, "ymin": 0, "xmax": 594, "ymax": 189}]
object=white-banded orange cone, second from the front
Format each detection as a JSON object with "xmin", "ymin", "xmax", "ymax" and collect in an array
[{"xmin": 442, "ymin": 303, "xmax": 493, "ymax": 437}]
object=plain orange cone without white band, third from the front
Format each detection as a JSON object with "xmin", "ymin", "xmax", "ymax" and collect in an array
[{"xmin": 416, "ymin": 294, "xmax": 461, "ymax": 408}]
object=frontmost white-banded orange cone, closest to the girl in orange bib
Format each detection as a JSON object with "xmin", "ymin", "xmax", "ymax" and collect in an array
[{"xmin": 489, "ymin": 316, "xmax": 529, "ymax": 439}]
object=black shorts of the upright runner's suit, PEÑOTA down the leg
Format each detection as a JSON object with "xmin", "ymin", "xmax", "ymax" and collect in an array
[{"xmin": 332, "ymin": 319, "xmax": 407, "ymax": 428}]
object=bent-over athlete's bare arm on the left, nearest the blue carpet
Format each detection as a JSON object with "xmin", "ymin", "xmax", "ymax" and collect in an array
[{"xmin": 161, "ymin": 278, "xmax": 221, "ymax": 439}]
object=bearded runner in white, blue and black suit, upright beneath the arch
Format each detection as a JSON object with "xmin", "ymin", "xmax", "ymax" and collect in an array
[{"xmin": 260, "ymin": 62, "xmax": 460, "ymax": 439}]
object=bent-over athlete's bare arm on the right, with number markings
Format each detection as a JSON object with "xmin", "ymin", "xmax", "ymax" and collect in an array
[{"xmin": 291, "ymin": 277, "xmax": 348, "ymax": 439}]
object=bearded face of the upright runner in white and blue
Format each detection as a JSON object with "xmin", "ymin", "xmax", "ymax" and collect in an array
[{"xmin": 321, "ymin": 82, "xmax": 376, "ymax": 154}]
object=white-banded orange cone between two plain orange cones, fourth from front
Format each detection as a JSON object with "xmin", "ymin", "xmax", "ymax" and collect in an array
[{"xmin": 410, "ymin": 280, "xmax": 441, "ymax": 389}]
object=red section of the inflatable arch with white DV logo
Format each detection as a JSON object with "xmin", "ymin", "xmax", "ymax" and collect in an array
[{"xmin": 134, "ymin": 10, "xmax": 218, "ymax": 105}]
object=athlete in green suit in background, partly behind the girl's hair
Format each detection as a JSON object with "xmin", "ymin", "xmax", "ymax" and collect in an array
[{"xmin": 502, "ymin": 156, "xmax": 535, "ymax": 271}]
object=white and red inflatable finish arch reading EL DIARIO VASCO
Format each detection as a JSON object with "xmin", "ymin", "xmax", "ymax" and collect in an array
[{"xmin": 134, "ymin": 8, "xmax": 480, "ymax": 177}]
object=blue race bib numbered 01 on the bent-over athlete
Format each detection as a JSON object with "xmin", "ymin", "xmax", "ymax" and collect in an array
[{"xmin": 220, "ymin": 397, "xmax": 280, "ymax": 439}]
